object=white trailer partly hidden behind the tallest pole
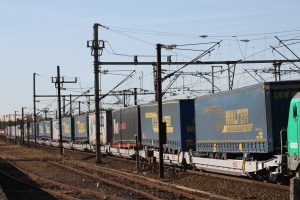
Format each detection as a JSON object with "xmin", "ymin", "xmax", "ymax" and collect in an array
[{"xmin": 89, "ymin": 111, "xmax": 112, "ymax": 145}]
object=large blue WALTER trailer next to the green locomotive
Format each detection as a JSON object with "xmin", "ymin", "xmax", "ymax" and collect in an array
[{"xmin": 195, "ymin": 81, "xmax": 300, "ymax": 155}]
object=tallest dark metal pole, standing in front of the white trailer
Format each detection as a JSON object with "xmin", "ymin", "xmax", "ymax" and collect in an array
[{"xmin": 93, "ymin": 23, "xmax": 101, "ymax": 164}]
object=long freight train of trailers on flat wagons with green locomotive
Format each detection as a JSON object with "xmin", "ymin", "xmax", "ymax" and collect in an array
[{"xmin": 1, "ymin": 81, "xmax": 300, "ymax": 181}]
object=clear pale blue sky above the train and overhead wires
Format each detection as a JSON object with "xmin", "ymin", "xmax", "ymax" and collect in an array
[{"xmin": 0, "ymin": 0, "xmax": 300, "ymax": 114}]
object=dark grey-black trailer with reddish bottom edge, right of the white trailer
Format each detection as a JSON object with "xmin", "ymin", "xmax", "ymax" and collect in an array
[{"xmin": 112, "ymin": 106, "xmax": 141, "ymax": 148}]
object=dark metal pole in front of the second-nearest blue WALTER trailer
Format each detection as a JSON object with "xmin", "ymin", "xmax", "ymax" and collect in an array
[{"xmin": 156, "ymin": 44, "xmax": 164, "ymax": 178}]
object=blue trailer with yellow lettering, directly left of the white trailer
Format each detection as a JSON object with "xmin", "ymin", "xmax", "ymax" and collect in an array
[{"xmin": 74, "ymin": 114, "xmax": 89, "ymax": 143}]
